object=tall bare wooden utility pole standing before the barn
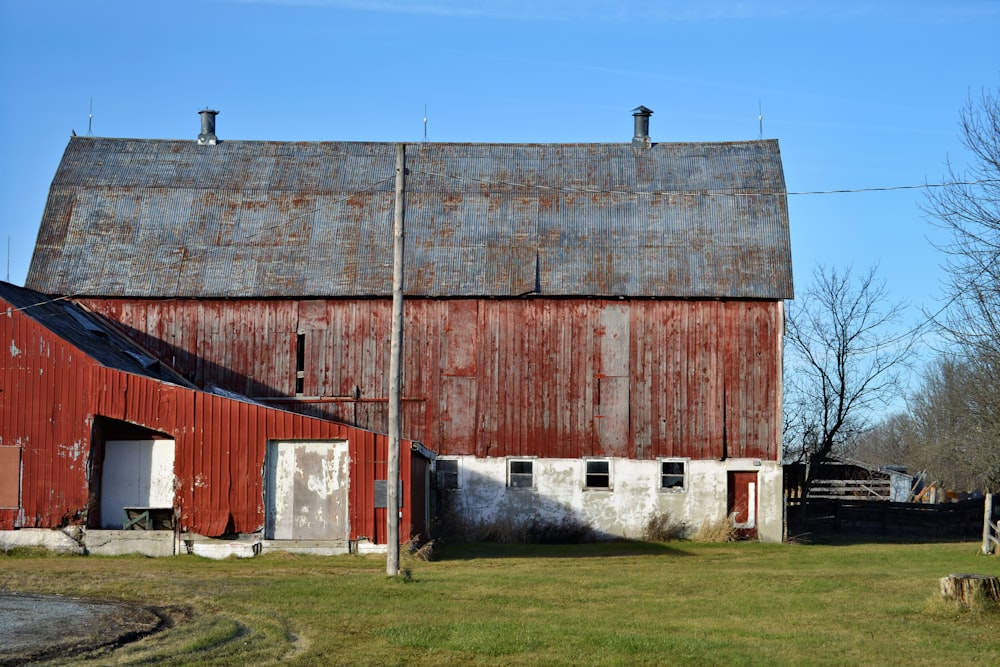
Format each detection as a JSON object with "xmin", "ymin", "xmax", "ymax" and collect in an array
[{"xmin": 385, "ymin": 144, "xmax": 406, "ymax": 577}]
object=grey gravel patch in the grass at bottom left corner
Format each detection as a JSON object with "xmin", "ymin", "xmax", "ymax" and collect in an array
[{"xmin": 0, "ymin": 593, "xmax": 165, "ymax": 667}]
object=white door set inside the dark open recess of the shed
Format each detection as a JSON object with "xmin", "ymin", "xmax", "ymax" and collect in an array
[{"xmin": 101, "ymin": 440, "xmax": 174, "ymax": 529}]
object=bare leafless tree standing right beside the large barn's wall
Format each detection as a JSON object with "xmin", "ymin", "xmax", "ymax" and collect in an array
[{"xmin": 785, "ymin": 267, "xmax": 914, "ymax": 486}]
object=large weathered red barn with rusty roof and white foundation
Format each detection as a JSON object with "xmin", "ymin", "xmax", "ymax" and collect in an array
[{"xmin": 15, "ymin": 108, "xmax": 792, "ymax": 540}]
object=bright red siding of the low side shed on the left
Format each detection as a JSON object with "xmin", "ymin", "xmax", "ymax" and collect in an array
[{"xmin": 0, "ymin": 300, "xmax": 426, "ymax": 542}]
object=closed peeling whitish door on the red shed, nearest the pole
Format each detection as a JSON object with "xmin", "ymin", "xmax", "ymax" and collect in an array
[{"xmin": 264, "ymin": 441, "xmax": 350, "ymax": 541}]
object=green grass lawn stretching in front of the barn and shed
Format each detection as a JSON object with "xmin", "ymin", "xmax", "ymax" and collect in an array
[{"xmin": 0, "ymin": 542, "xmax": 1000, "ymax": 666}]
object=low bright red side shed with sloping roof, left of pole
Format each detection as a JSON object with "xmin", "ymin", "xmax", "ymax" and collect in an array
[{"xmin": 0, "ymin": 283, "xmax": 433, "ymax": 550}]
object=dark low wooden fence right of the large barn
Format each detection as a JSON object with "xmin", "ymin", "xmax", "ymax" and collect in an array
[{"xmin": 786, "ymin": 498, "xmax": 1000, "ymax": 540}]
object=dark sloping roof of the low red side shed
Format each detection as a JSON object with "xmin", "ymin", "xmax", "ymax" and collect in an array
[{"xmin": 0, "ymin": 281, "xmax": 194, "ymax": 387}]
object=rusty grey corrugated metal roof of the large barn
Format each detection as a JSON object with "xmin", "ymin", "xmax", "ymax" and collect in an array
[{"xmin": 27, "ymin": 137, "xmax": 792, "ymax": 299}]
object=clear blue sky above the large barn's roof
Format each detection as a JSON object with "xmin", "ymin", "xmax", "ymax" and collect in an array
[{"xmin": 0, "ymin": 0, "xmax": 1000, "ymax": 388}]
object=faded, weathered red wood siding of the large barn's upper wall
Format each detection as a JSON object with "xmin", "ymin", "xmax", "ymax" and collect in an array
[{"xmin": 80, "ymin": 298, "xmax": 783, "ymax": 460}]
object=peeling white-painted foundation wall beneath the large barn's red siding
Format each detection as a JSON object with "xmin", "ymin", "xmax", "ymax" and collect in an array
[{"xmin": 442, "ymin": 456, "xmax": 784, "ymax": 542}]
